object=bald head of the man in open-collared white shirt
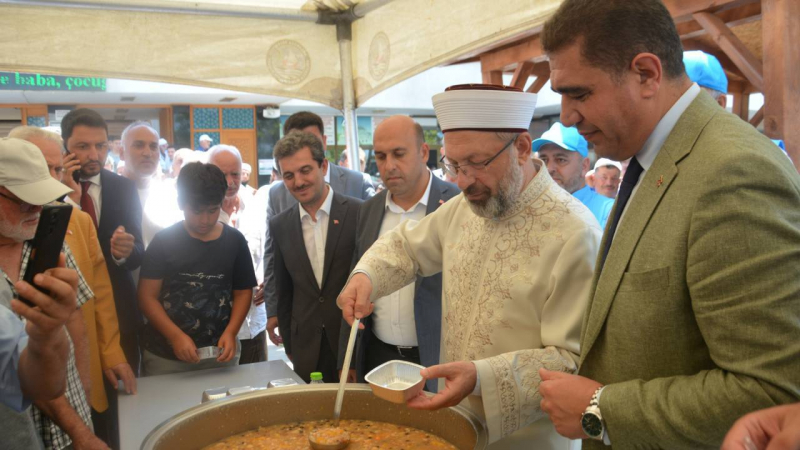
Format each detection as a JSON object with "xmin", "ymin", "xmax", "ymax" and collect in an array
[{"xmin": 372, "ymin": 116, "xmax": 430, "ymax": 206}]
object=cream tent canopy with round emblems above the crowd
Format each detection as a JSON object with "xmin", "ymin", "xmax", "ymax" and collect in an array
[{"xmin": 0, "ymin": 0, "xmax": 560, "ymax": 109}]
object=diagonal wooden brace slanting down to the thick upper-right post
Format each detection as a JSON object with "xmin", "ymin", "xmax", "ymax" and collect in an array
[{"xmin": 692, "ymin": 12, "xmax": 764, "ymax": 91}]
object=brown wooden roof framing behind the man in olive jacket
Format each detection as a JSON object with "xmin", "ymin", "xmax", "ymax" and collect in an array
[{"xmin": 460, "ymin": 0, "xmax": 800, "ymax": 171}]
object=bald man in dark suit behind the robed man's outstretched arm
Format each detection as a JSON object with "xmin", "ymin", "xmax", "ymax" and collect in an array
[{"xmin": 339, "ymin": 116, "xmax": 459, "ymax": 392}]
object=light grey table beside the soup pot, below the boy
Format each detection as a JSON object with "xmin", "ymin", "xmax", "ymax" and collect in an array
[{"xmin": 118, "ymin": 360, "xmax": 305, "ymax": 450}]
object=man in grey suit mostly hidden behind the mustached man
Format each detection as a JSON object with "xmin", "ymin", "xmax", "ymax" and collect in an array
[{"xmin": 262, "ymin": 111, "xmax": 375, "ymax": 345}]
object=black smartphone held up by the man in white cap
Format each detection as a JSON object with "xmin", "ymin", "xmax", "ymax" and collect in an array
[{"xmin": 20, "ymin": 203, "xmax": 72, "ymax": 306}]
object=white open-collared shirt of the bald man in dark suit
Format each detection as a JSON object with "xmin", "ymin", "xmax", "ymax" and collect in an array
[{"xmin": 372, "ymin": 172, "xmax": 432, "ymax": 347}]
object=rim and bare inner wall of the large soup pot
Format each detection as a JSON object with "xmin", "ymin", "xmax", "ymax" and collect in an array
[{"xmin": 142, "ymin": 384, "xmax": 488, "ymax": 450}]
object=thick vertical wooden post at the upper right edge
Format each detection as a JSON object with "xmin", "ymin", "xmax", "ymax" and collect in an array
[{"xmin": 761, "ymin": 0, "xmax": 800, "ymax": 171}]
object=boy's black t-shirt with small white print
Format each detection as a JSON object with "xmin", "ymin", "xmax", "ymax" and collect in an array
[{"xmin": 140, "ymin": 222, "xmax": 257, "ymax": 359}]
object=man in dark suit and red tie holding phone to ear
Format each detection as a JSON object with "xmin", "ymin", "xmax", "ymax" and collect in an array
[{"xmin": 61, "ymin": 108, "xmax": 144, "ymax": 375}]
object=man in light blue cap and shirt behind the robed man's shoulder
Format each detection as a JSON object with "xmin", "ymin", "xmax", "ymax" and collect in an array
[{"xmin": 532, "ymin": 122, "xmax": 614, "ymax": 228}]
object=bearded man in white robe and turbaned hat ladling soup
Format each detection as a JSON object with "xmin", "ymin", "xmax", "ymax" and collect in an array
[{"xmin": 339, "ymin": 85, "xmax": 602, "ymax": 449}]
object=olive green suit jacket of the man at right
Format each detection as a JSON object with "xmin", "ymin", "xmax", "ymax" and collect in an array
[{"xmin": 580, "ymin": 92, "xmax": 800, "ymax": 449}]
